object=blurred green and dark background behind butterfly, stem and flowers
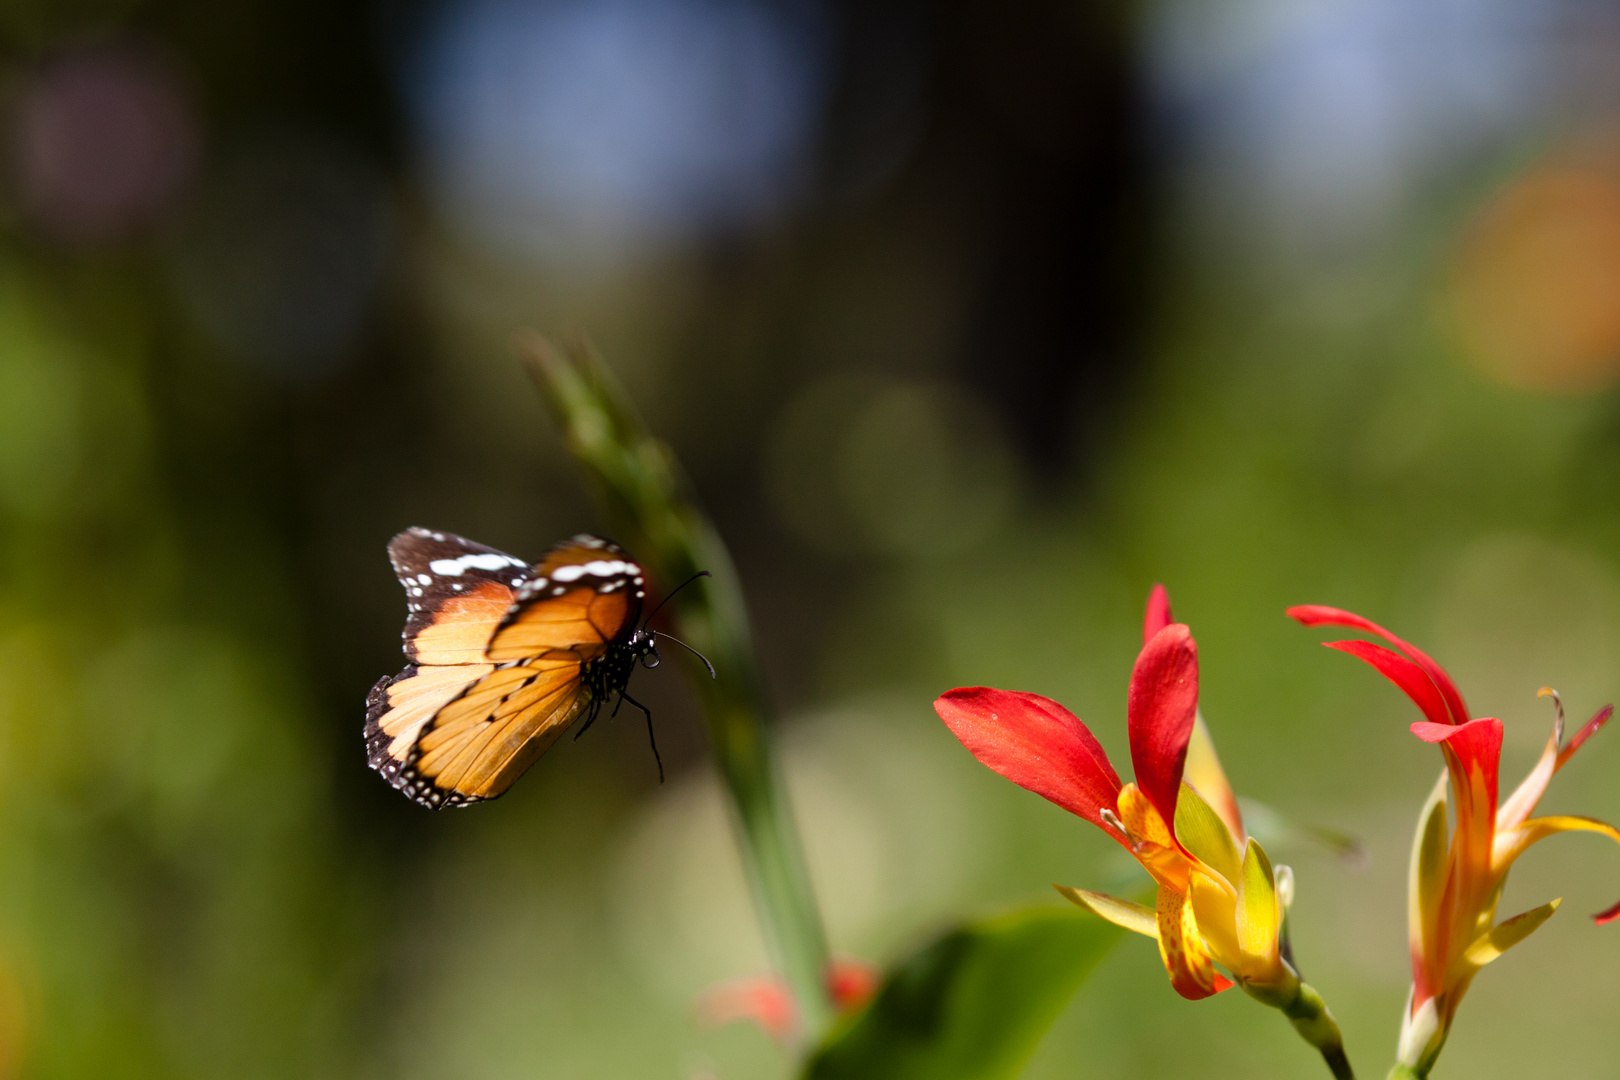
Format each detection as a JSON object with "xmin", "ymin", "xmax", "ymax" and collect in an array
[{"xmin": 0, "ymin": 0, "xmax": 1620, "ymax": 1080}]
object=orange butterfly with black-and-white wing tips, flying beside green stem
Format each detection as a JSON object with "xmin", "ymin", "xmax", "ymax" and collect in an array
[{"xmin": 366, "ymin": 528, "xmax": 693, "ymax": 810}]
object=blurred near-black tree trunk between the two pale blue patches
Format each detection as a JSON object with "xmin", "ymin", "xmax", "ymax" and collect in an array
[{"xmin": 932, "ymin": 0, "xmax": 1149, "ymax": 479}]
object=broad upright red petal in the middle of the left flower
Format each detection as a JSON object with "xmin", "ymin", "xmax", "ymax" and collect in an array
[{"xmin": 1126, "ymin": 622, "xmax": 1199, "ymax": 823}]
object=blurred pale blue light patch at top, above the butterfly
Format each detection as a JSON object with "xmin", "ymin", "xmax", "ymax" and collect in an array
[{"xmin": 410, "ymin": 0, "xmax": 823, "ymax": 257}]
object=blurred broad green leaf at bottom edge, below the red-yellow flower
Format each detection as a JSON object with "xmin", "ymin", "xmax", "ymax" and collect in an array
[{"xmin": 802, "ymin": 907, "xmax": 1119, "ymax": 1080}]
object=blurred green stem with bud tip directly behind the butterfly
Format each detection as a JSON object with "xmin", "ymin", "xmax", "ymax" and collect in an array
[{"xmin": 517, "ymin": 334, "xmax": 831, "ymax": 1043}]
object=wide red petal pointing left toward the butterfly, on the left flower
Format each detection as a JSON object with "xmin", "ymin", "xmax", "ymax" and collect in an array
[{"xmin": 933, "ymin": 687, "xmax": 1126, "ymax": 844}]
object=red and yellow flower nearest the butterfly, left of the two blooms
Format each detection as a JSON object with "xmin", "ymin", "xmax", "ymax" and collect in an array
[{"xmin": 935, "ymin": 586, "xmax": 1276, "ymax": 1004}]
